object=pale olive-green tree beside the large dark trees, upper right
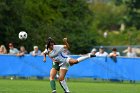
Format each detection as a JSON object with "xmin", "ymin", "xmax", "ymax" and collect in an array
[{"xmin": 91, "ymin": 2, "xmax": 126, "ymax": 30}]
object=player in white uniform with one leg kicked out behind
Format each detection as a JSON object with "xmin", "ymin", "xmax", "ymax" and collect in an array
[{"xmin": 44, "ymin": 38, "xmax": 95, "ymax": 93}]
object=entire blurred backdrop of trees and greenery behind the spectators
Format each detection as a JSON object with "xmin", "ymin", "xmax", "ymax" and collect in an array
[{"xmin": 0, "ymin": 0, "xmax": 140, "ymax": 54}]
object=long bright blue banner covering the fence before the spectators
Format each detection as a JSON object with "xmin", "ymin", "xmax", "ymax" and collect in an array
[{"xmin": 0, "ymin": 55, "xmax": 140, "ymax": 80}]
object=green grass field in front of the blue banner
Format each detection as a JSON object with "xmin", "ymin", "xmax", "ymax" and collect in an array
[{"xmin": 0, "ymin": 79, "xmax": 140, "ymax": 93}]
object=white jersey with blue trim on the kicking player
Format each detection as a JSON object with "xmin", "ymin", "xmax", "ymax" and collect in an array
[{"xmin": 44, "ymin": 45, "xmax": 68, "ymax": 63}]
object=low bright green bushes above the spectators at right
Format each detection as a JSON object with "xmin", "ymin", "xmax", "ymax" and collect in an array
[{"xmin": 101, "ymin": 28, "xmax": 140, "ymax": 46}]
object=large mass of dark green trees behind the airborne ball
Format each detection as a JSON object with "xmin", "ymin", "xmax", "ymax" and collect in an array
[{"xmin": 0, "ymin": 0, "xmax": 95, "ymax": 53}]
